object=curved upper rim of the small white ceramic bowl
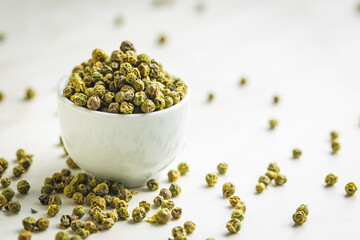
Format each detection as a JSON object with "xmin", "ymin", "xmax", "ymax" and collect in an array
[{"xmin": 56, "ymin": 76, "xmax": 191, "ymax": 118}]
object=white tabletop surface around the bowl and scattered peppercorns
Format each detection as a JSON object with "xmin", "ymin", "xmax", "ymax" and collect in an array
[{"xmin": 0, "ymin": 0, "xmax": 360, "ymax": 240}]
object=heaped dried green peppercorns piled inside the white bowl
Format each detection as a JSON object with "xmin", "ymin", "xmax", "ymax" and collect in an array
[{"xmin": 63, "ymin": 41, "xmax": 187, "ymax": 114}]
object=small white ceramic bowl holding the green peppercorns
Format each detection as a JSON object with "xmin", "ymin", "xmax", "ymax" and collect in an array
[{"xmin": 57, "ymin": 78, "xmax": 190, "ymax": 187}]
